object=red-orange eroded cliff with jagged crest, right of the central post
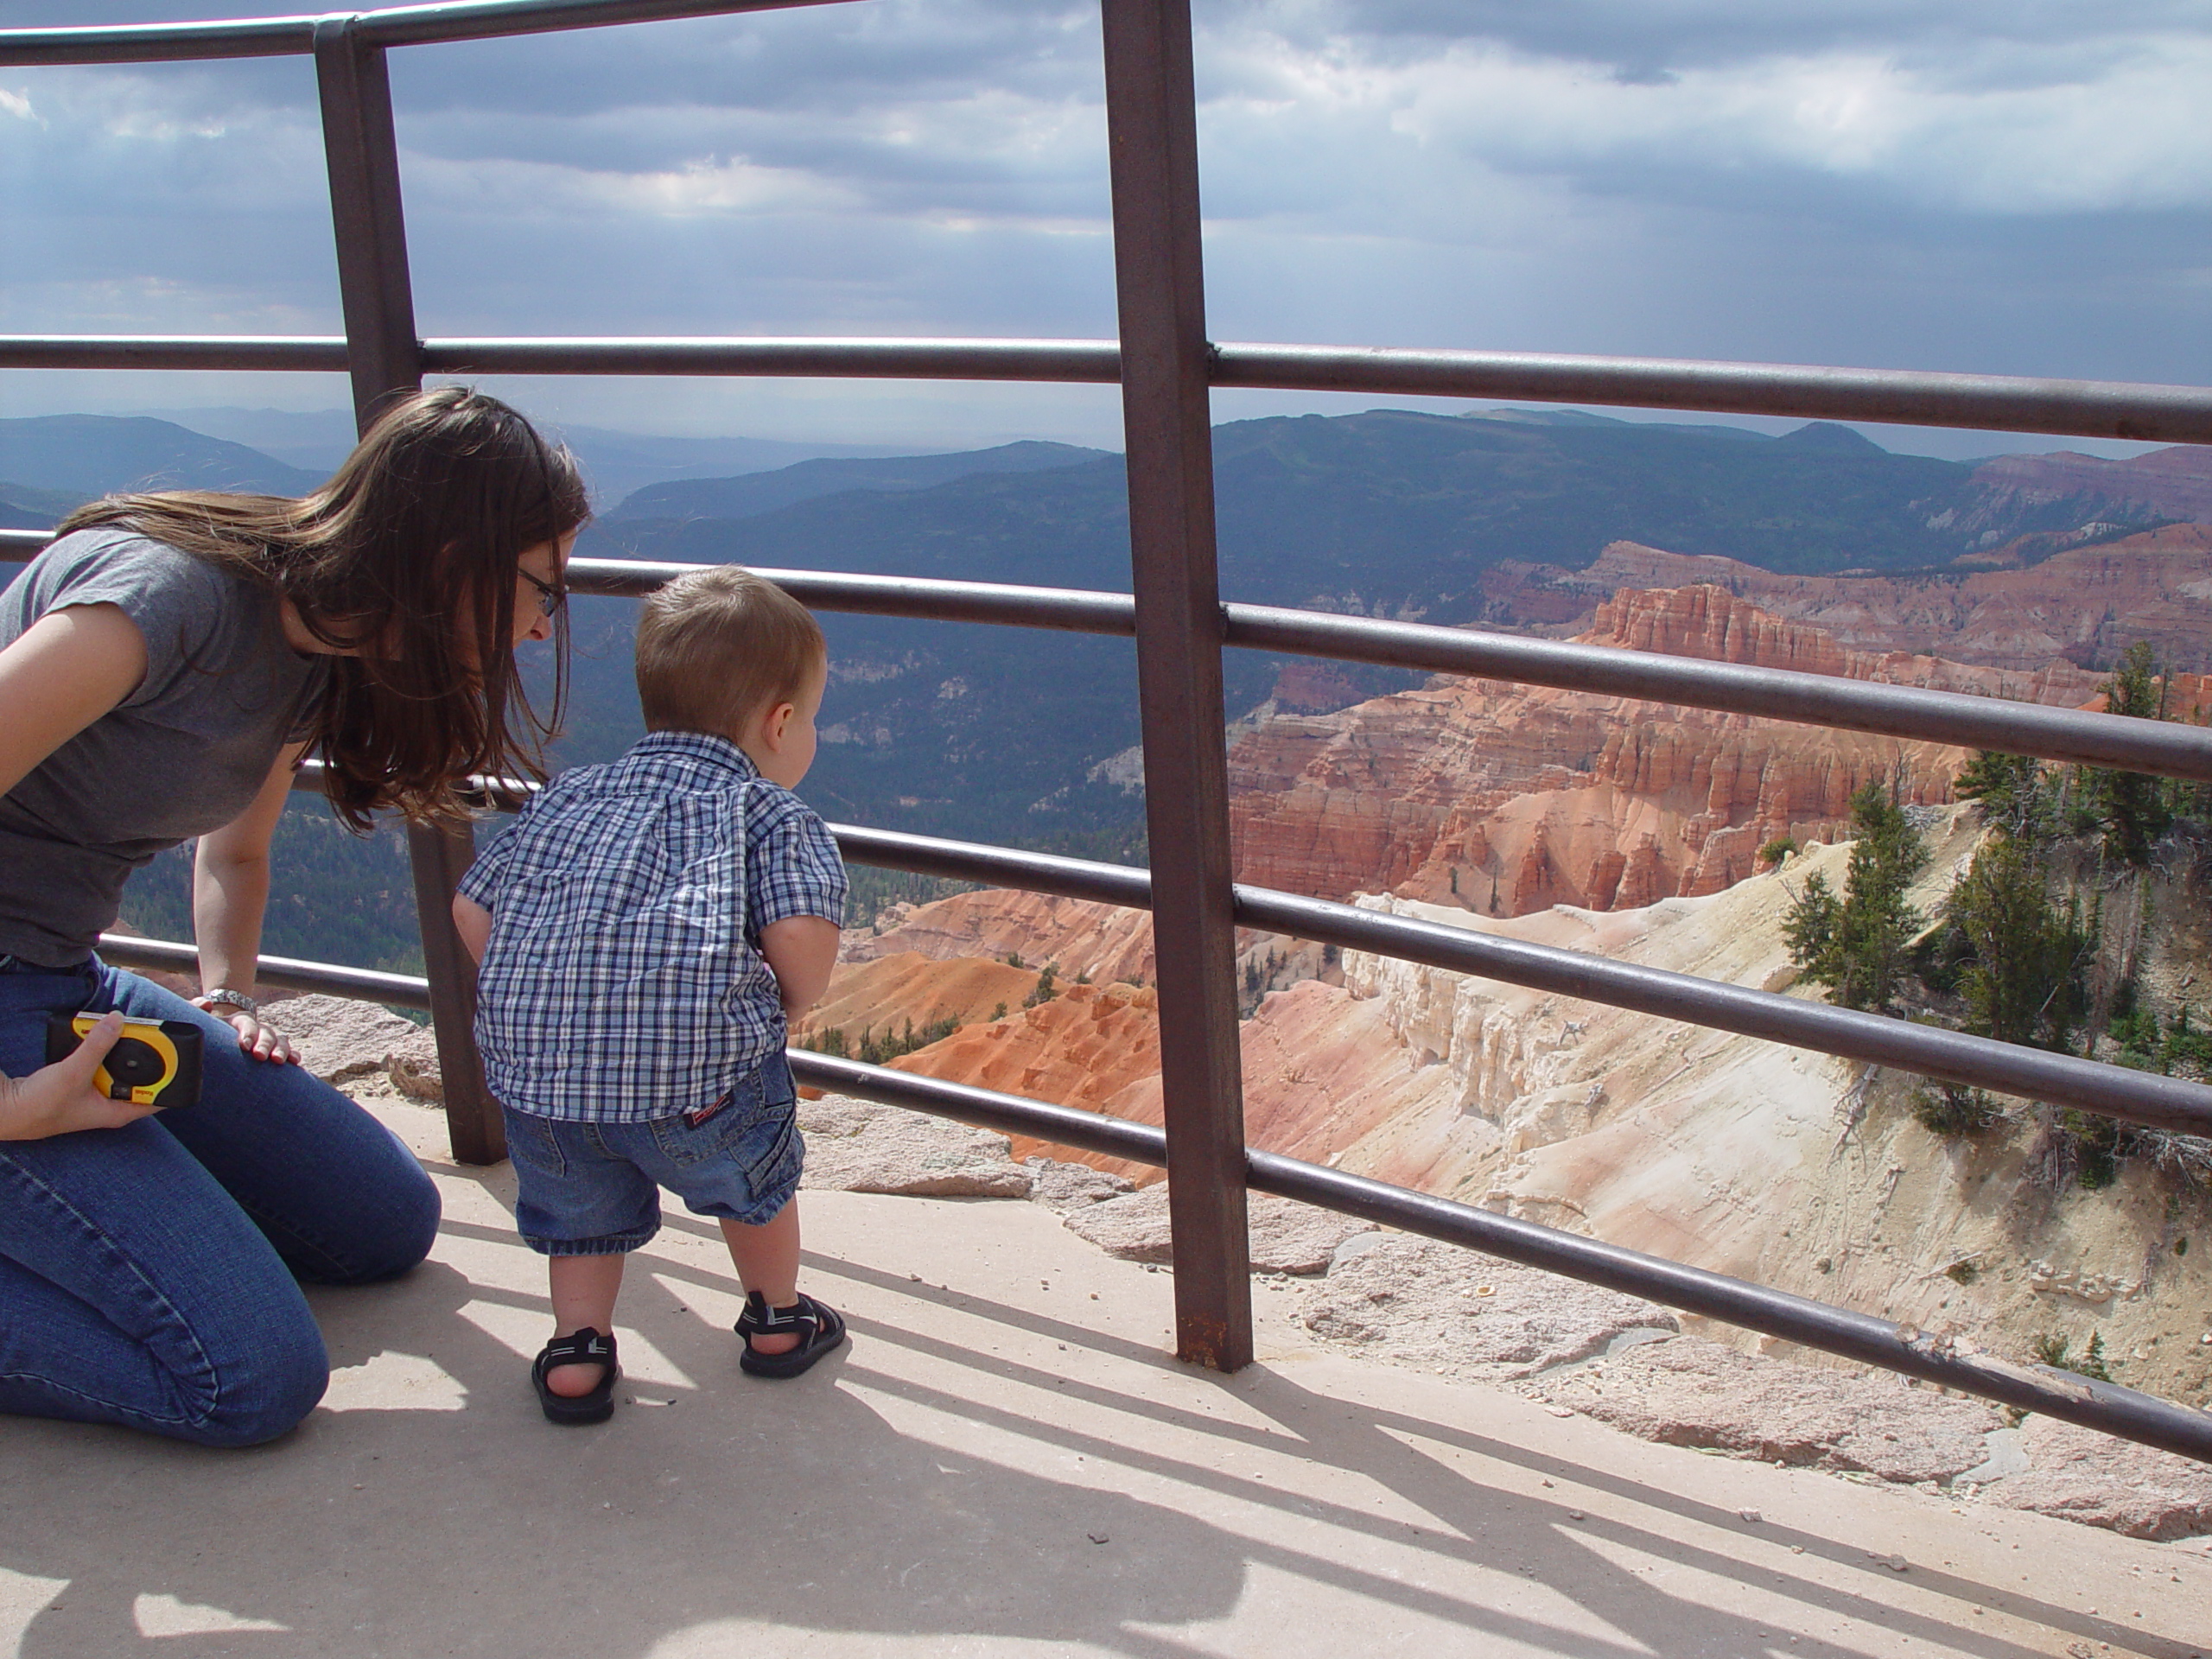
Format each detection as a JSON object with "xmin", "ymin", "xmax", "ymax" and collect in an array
[{"xmin": 1230, "ymin": 584, "xmax": 2070, "ymax": 916}]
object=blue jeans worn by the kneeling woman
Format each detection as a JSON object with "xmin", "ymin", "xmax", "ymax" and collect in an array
[{"xmin": 0, "ymin": 957, "xmax": 438, "ymax": 1446}]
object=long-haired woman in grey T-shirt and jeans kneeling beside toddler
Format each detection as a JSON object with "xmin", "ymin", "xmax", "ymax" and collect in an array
[{"xmin": 0, "ymin": 387, "xmax": 588, "ymax": 1446}]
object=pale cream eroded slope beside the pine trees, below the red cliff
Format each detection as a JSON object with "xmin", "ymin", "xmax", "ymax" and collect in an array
[{"xmin": 1309, "ymin": 827, "xmax": 2212, "ymax": 1402}]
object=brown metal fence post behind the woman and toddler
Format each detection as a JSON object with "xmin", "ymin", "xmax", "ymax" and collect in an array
[{"xmin": 315, "ymin": 16, "xmax": 506, "ymax": 1164}]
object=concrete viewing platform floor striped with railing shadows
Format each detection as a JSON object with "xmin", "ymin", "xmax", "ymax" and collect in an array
[{"xmin": 0, "ymin": 1102, "xmax": 2212, "ymax": 1659}]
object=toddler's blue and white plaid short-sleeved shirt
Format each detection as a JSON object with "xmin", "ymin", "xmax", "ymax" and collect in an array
[{"xmin": 460, "ymin": 732, "xmax": 845, "ymax": 1123}]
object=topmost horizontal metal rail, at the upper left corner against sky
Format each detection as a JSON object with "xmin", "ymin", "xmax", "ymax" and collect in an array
[{"xmin": 0, "ymin": 0, "xmax": 827, "ymax": 67}]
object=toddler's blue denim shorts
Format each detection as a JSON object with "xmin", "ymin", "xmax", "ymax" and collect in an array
[{"xmin": 506, "ymin": 1053, "xmax": 807, "ymax": 1256}]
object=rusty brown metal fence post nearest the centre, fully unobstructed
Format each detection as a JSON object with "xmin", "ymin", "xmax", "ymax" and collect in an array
[{"xmin": 1103, "ymin": 0, "xmax": 1252, "ymax": 1371}]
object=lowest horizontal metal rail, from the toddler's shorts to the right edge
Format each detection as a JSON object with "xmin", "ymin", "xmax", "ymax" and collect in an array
[{"xmin": 790, "ymin": 1048, "xmax": 2212, "ymax": 1462}]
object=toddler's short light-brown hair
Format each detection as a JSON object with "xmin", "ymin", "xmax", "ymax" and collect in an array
[{"xmin": 637, "ymin": 564, "xmax": 830, "ymax": 736}]
